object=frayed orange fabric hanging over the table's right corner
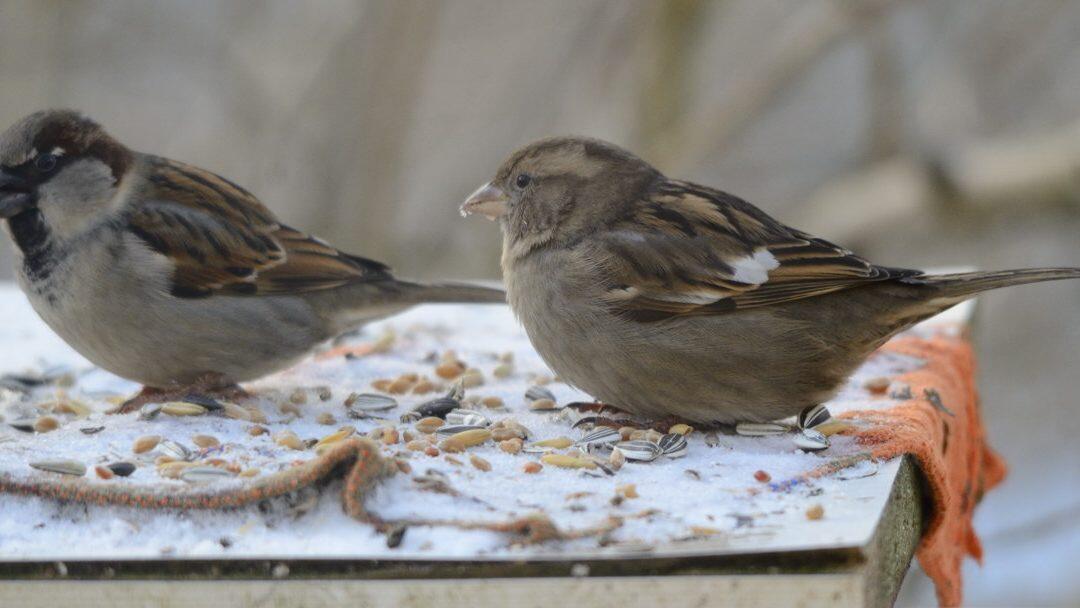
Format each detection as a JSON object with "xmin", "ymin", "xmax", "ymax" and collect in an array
[{"xmin": 842, "ymin": 336, "xmax": 1005, "ymax": 606}]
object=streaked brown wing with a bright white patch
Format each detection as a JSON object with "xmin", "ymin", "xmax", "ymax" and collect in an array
[{"xmin": 591, "ymin": 180, "xmax": 920, "ymax": 322}]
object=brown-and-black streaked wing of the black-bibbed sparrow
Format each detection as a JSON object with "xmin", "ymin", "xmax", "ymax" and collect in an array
[{"xmin": 127, "ymin": 158, "xmax": 390, "ymax": 298}]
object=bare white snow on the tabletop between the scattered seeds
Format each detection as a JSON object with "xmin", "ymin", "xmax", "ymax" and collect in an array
[{"xmin": 0, "ymin": 285, "xmax": 967, "ymax": 560}]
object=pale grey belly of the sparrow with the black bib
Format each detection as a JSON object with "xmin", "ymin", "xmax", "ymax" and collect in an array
[{"xmin": 19, "ymin": 233, "xmax": 328, "ymax": 387}]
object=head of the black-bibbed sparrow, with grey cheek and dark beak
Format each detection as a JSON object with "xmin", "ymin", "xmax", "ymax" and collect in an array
[{"xmin": 0, "ymin": 110, "xmax": 134, "ymax": 235}]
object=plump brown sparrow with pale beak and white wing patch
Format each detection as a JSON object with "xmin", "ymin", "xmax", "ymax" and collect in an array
[{"xmin": 461, "ymin": 137, "xmax": 1080, "ymax": 424}]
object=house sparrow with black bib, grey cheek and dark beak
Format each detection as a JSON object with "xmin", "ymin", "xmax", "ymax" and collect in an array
[{"xmin": 0, "ymin": 111, "xmax": 504, "ymax": 410}]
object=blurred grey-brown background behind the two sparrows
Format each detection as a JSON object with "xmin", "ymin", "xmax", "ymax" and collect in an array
[{"xmin": 0, "ymin": 0, "xmax": 1080, "ymax": 606}]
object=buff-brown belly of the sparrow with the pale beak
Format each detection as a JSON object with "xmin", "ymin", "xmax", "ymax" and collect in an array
[{"xmin": 508, "ymin": 257, "xmax": 876, "ymax": 423}]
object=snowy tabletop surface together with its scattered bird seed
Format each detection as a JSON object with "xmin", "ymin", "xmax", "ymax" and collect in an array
[{"xmin": 0, "ymin": 299, "xmax": 919, "ymax": 559}]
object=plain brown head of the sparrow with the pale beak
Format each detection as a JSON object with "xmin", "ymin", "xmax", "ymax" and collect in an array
[{"xmin": 461, "ymin": 137, "xmax": 663, "ymax": 255}]
